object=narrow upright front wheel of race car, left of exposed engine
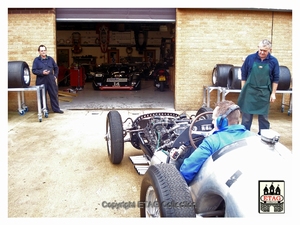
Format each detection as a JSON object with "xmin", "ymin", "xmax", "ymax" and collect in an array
[{"xmin": 106, "ymin": 111, "xmax": 124, "ymax": 164}]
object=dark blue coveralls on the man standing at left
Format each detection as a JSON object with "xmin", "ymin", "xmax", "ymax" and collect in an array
[{"xmin": 32, "ymin": 56, "xmax": 60, "ymax": 112}]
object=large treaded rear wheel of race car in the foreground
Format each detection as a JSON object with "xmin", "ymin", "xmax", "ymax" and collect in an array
[{"xmin": 139, "ymin": 163, "xmax": 196, "ymax": 217}]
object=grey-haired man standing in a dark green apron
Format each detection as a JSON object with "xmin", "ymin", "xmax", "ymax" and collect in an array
[{"xmin": 238, "ymin": 39, "xmax": 279, "ymax": 134}]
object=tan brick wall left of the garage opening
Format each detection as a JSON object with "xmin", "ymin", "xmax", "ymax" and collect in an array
[{"xmin": 8, "ymin": 8, "xmax": 56, "ymax": 111}]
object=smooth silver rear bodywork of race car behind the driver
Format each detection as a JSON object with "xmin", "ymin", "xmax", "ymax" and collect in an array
[{"xmin": 189, "ymin": 131, "xmax": 292, "ymax": 217}]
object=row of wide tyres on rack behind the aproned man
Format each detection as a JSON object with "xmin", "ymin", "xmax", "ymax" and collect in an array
[{"xmin": 212, "ymin": 64, "xmax": 291, "ymax": 90}]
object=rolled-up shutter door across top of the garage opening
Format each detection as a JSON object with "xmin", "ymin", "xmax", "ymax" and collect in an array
[{"xmin": 56, "ymin": 8, "xmax": 176, "ymax": 22}]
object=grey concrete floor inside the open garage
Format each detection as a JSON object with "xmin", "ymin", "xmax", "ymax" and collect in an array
[{"xmin": 59, "ymin": 79, "xmax": 174, "ymax": 110}]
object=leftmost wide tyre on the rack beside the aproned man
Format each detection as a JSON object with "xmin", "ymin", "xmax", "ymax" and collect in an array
[{"xmin": 212, "ymin": 64, "xmax": 233, "ymax": 87}]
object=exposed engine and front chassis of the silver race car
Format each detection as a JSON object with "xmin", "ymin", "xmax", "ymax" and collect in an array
[{"xmin": 123, "ymin": 112, "xmax": 212, "ymax": 174}]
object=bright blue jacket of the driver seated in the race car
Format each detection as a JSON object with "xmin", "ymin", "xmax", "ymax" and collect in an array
[{"xmin": 180, "ymin": 124, "xmax": 255, "ymax": 184}]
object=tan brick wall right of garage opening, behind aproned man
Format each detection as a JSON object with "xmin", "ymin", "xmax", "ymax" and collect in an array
[{"xmin": 175, "ymin": 9, "xmax": 292, "ymax": 110}]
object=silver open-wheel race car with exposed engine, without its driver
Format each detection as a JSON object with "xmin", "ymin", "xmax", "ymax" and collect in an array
[{"xmin": 105, "ymin": 107, "xmax": 292, "ymax": 217}]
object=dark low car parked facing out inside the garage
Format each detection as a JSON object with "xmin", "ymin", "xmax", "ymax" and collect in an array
[{"xmin": 93, "ymin": 63, "xmax": 141, "ymax": 90}]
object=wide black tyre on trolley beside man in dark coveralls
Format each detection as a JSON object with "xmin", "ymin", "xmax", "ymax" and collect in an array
[{"xmin": 7, "ymin": 61, "xmax": 31, "ymax": 88}]
